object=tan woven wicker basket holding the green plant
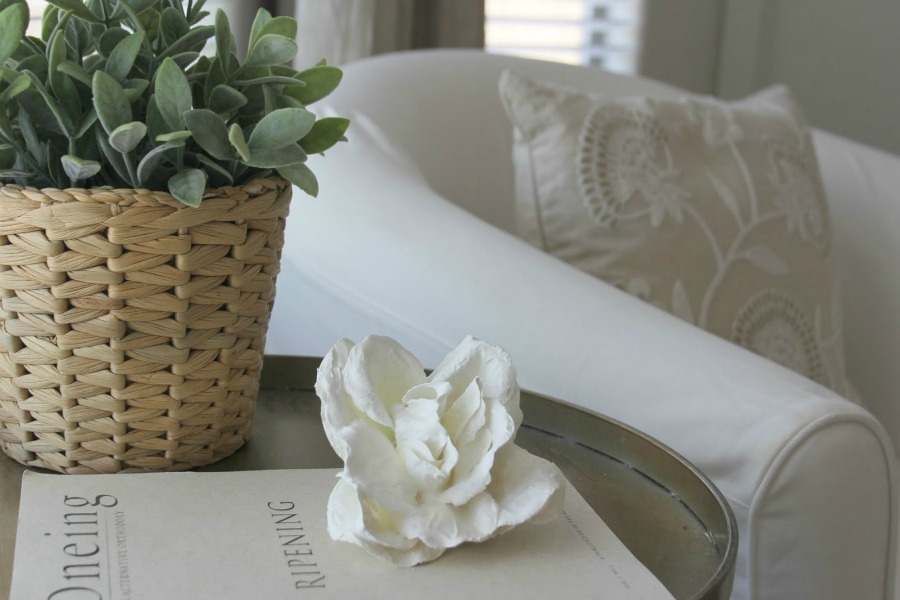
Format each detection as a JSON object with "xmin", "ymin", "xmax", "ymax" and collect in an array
[{"xmin": 0, "ymin": 179, "xmax": 291, "ymax": 473}]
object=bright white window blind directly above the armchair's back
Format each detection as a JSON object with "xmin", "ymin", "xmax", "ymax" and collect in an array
[{"xmin": 485, "ymin": 0, "xmax": 644, "ymax": 73}]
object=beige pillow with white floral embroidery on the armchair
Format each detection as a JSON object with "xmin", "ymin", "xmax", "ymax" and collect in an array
[{"xmin": 500, "ymin": 72, "xmax": 853, "ymax": 397}]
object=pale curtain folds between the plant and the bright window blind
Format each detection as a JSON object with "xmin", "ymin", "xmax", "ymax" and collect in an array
[{"xmin": 277, "ymin": 0, "xmax": 484, "ymax": 65}]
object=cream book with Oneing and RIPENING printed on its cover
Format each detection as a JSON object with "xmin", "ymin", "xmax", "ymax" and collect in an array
[{"xmin": 10, "ymin": 469, "xmax": 672, "ymax": 600}]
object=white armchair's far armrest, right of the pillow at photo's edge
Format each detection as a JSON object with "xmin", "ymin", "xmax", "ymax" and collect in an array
[{"xmin": 813, "ymin": 131, "xmax": 900, "ymax": 460}]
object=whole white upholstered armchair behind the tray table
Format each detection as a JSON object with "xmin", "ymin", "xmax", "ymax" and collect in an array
[{"xmin": 267, "ymin": 51, "xmax": 900, "ymax": 600}]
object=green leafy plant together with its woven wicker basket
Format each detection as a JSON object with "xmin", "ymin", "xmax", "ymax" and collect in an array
[{"xmin": 0, "ymin": 0, "xmax": 349, "ymax": 473}]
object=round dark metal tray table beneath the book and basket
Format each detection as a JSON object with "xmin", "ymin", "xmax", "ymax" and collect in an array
[{"xmin": 0, "ymin": 356, "xmax": 737, "ymax": 600}]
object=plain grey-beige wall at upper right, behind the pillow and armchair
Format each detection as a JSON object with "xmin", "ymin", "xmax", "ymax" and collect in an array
[{"xmin": 641, "ymin": 0, "xmax": 900, "ymax": 154}]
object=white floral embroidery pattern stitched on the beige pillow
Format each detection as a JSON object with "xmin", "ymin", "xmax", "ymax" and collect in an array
[{"xmin": 576, "ymin": 92, "xmax": 830, "ymax": 385}]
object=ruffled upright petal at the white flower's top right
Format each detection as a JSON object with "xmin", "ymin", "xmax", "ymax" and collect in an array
[{"xmin": 428, "ymin": 336, "xmax": 522, "ymax": 429}]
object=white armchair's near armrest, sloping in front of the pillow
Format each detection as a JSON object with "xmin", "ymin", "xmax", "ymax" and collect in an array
[{"xmin": 267, "ymin": 117, "xmax": 897, "ymax": 599}]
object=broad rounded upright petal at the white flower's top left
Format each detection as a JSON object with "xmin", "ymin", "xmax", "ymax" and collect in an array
[{"xmin": 343, "ymin": 335, "xmax": 425, "ymax": 427}]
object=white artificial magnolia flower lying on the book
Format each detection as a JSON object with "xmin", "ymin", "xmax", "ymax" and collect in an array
[{"xmin": 316, "ymin": 336, "xmax": 565, "ymax": 567}]
